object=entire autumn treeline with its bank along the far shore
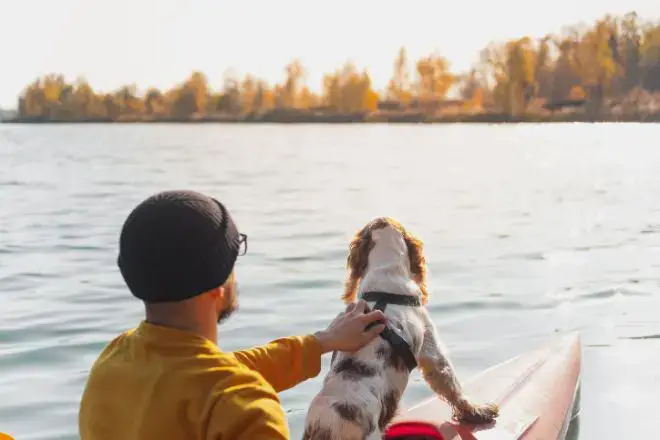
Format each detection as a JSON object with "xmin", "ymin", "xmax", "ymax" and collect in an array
[{"xmin": 7, "ymin": 12, "xmax": 660, "ymax": 122}]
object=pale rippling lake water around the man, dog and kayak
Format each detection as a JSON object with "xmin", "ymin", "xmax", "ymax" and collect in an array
[{"xmin": 0, "ymin": 124, "xmax": 660, "ymax": 440}]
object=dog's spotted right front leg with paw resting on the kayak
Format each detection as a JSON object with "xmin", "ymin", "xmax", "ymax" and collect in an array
[{"xmin": 417, "ymin": 309, "xmax": 499, "ymax": 425}]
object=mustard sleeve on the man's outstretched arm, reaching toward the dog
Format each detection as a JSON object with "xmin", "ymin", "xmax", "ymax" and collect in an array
[{"xmin": 233, "ymin": 335, "xmax": 321, "ymax": 393}]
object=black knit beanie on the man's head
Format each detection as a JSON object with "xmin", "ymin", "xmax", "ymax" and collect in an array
[{"xmin": 117, "ymin": 191, "xmax": 240, "ymax": 302}]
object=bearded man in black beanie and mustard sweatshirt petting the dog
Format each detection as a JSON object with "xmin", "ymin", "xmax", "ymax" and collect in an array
[{"xmin": 79, "ymin": 191, "xmax": 385, "ymax": 440}]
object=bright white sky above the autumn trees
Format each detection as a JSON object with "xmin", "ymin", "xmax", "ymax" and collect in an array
[{"xmin": 0, "ymin": 0, "xmax": 660, "ymax": 108}]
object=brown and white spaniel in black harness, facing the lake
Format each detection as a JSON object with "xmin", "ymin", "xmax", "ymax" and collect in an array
[{"xmin": 303, "ymin": 217, "xmax": 499, "ymax": 440}]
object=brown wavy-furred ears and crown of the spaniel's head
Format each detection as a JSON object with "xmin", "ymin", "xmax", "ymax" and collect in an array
[{"xmin": 342, "ymin": 217, "xmax": 428, "ymax": 304}]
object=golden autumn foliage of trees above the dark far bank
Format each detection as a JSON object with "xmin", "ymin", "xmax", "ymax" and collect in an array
[{"xmin": 12, "ymin": 13, "xmax": 660, "ymax": 120}]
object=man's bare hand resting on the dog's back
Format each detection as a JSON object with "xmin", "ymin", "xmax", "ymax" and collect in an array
[{"xmin": 314, "ymin": 300, "xmax": 387, "ymax": 353}]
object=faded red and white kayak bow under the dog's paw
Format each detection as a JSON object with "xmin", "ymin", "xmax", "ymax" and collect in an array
[{"xmin": 384, "ymin": 332, "xmax": 582, "ymax": 440}]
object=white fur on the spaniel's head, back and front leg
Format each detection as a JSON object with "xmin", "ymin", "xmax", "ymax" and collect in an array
[{"xmin": 303, "ymin": 226, "xmax": 480, "ymax": 440}]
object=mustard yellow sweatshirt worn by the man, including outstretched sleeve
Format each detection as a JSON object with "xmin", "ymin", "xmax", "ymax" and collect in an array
[{"xmin": 79, "ymin": 322, "xmax": 321, "ymax": 440}]
